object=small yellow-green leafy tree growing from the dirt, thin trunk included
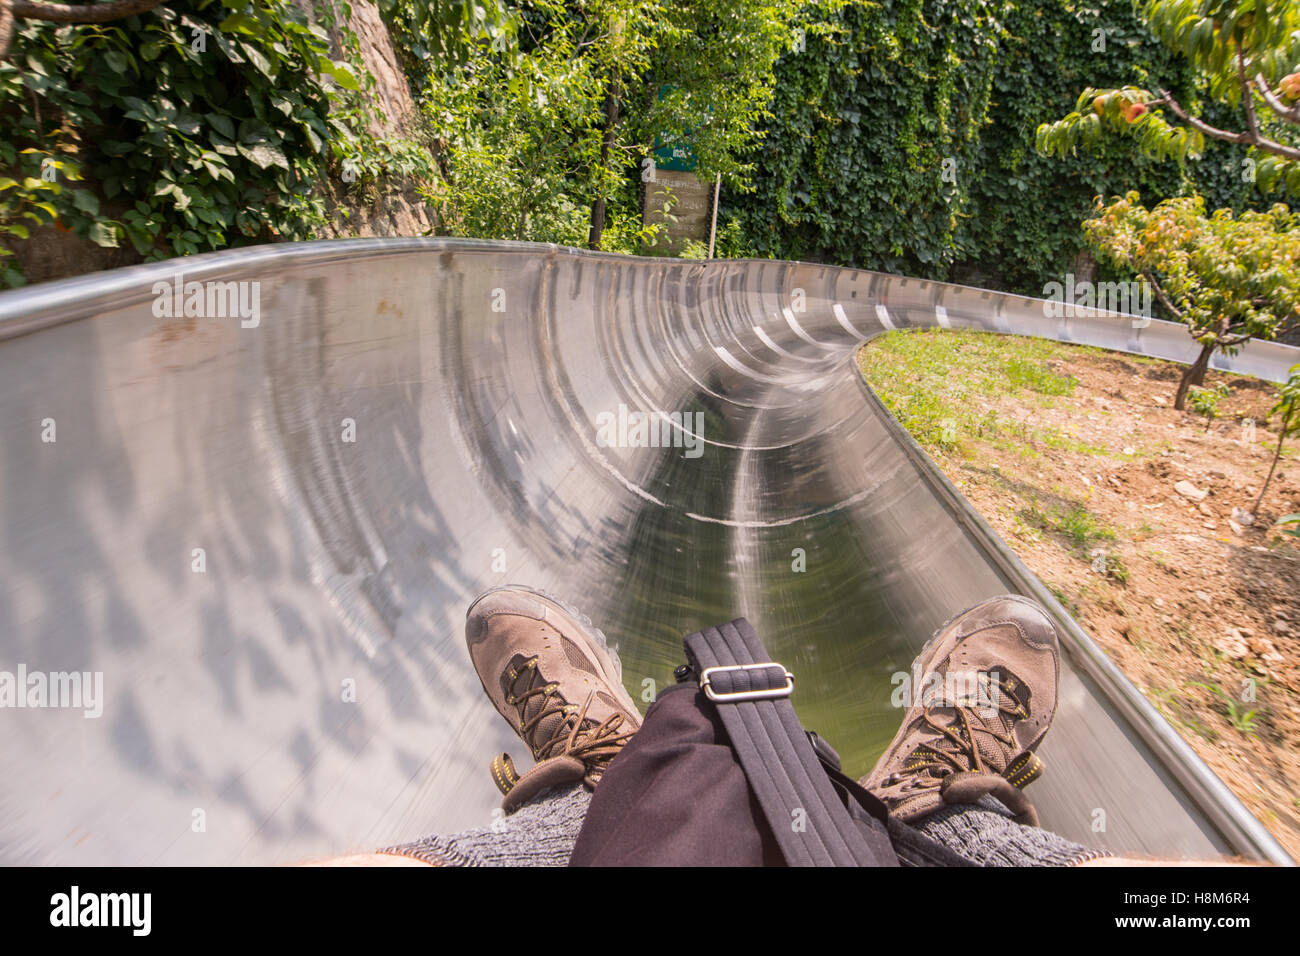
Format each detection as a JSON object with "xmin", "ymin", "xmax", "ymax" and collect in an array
[{"xmin": 1083, "ymin": 193, "xmax": 1300, "ymax": 410}]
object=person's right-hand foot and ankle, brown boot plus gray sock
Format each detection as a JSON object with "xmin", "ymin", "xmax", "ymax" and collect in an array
[{"xmin": 861, "ymin": 596, "xmax": 1108, "ymax": 866}]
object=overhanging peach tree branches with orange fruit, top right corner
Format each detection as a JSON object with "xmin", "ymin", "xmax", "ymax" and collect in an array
[{"xmin": 1037, "ymin": 0, "xmax": 1300, "ymax": 194}]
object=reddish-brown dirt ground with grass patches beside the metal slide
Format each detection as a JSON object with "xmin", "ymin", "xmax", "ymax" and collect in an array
[{"xmin": 861, "ymin": 333, "xmax": 1300, "ymax": 858}]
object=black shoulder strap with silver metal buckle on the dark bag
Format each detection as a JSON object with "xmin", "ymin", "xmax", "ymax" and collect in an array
[{"xmin": 683, "ymin": 618, "xmax": 897, "ymax": 866}]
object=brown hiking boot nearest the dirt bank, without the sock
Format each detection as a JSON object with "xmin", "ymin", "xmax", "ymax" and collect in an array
[{"xmin": 861, "ymin": 594, "xmax": 1060, "ymax": 826}]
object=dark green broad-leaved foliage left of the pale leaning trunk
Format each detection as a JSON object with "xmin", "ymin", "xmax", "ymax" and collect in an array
[{"xmin": 0, "ymin": 0, "xmax": 450, "ymax": 286}]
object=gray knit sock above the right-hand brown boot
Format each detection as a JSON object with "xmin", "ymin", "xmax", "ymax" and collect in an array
[{"xmin": 911, "ymin": 797, "xmax": 1110, "ymax": 866}]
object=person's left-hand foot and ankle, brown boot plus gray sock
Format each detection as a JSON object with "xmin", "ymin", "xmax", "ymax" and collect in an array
[{"xmin": 367, "ymin": 585, "xmax": 641, "ymax": 866}]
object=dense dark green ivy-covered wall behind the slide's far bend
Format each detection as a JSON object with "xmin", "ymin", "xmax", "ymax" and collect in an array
[{"xmin": 720, "ymin": 0, "xmax": 1274, "ymax": 295}]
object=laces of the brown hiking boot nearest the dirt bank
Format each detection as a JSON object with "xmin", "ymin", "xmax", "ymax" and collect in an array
[{"xmin": 885, "ymin": 671, "xmax": 1030, "ymax": 790}]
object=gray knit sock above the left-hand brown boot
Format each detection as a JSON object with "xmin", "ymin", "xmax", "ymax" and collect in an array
[{"xmin": 380, "ymin": 783, "xmax": 592, "ymax": 866}]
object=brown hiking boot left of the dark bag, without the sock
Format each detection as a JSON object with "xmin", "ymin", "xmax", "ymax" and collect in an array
[{"xmin": 465, "ymin": 584, "xmax": 641, "ymax": 813}]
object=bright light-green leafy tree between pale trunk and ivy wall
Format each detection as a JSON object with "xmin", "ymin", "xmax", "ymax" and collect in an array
[{"xmin": 416, "ymin": 0, "xmax": 806, "ymax": 250}]
